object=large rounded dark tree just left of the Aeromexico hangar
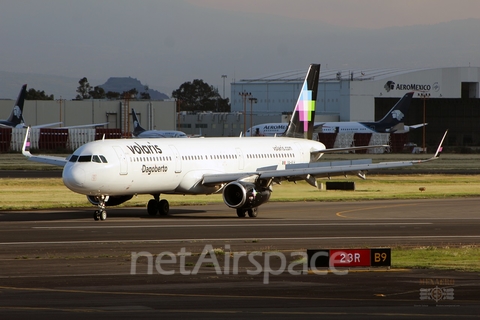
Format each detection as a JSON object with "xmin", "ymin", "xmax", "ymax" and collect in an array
[{"xmin": 172, "ymin": 79, "xmax": 230, "ymax": 112}]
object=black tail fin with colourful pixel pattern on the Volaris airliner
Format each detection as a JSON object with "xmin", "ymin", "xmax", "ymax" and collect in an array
[{"xmin": 283, "ymin": 64, "xmax": 320, "ymax": 140}]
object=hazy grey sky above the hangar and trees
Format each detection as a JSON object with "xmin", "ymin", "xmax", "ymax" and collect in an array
[{"xmin": 0, "ymin": 0, "xmax": 480, "ymax": 98}]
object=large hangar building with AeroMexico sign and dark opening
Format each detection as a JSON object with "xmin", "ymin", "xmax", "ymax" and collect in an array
[{"xmin": 231, "ymin": 67, "xmax": 480, "ymax": 146}]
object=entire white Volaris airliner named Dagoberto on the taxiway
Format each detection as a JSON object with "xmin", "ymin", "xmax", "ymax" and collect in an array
[{"xmin": 19, "ymin": 64, "xmax": 443, "ymax": 220}]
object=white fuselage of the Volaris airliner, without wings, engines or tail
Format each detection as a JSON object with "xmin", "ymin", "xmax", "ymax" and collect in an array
[{"xmin": 63, "ymin": 137, "xmax": 325, "ymax": 196}]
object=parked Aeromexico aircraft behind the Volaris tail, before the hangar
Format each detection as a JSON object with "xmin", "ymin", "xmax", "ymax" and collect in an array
[{"xmin": 246, "ymin": 92, "xmax": 426, "ymax": 136}]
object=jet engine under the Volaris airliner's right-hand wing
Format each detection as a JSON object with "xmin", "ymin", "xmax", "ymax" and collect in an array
[{"xmin": 223, "ymin": 181, "xmax": 272, "ymax": 209}]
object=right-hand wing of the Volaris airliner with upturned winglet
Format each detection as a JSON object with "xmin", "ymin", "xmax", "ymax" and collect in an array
[{"xmin": 202, "ymin": 131, "xmax": 448, "ymax": 186}]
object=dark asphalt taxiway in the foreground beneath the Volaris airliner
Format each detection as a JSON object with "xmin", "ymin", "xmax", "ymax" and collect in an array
[{"xmin": 0, "ymin": 198, "xmax": 480, "ymax": 319}]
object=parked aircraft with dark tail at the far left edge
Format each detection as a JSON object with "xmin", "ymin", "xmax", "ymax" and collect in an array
[{"xmin": 0, "ymin": 84, "xmax": 108, "ymax": 129}]
